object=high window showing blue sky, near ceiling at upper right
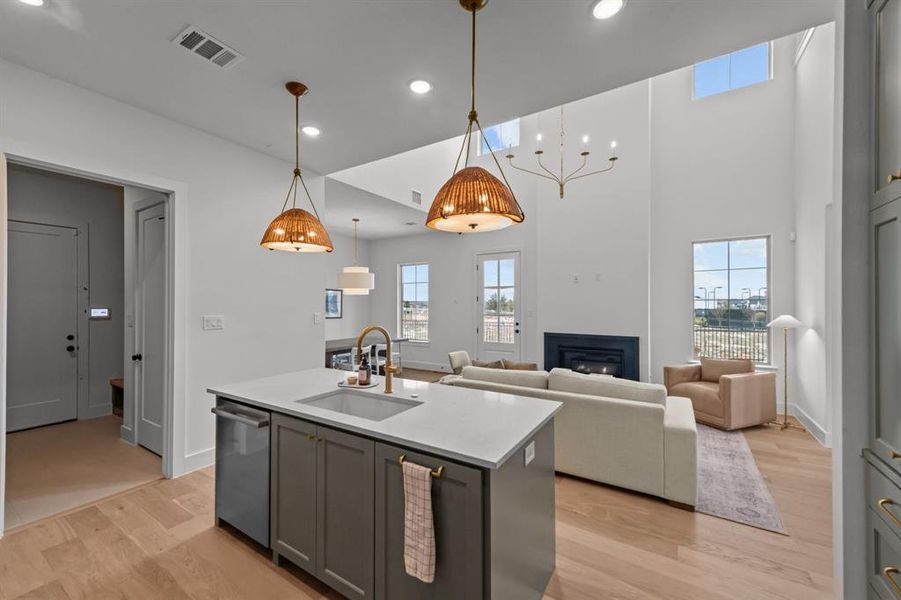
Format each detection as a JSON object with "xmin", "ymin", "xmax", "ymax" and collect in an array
[{"xmin": 694, "ymin": 42, "xmax": 773, "ymax": 99}]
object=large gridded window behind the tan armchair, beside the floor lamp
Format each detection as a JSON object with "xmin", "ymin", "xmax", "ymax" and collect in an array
[{"xmin": 693, "ymin": 237, "xmax": 770, "ymax": 364}]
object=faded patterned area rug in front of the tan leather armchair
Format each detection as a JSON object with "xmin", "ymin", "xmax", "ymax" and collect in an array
[{"xmin": 695, "ymin": 423, "xmax": 788, "ymax": 535}]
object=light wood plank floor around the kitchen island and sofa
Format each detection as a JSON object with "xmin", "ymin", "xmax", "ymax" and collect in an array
[{"xmin": 0, "ymin": 420, "xmax": 832, "ymax": 600}]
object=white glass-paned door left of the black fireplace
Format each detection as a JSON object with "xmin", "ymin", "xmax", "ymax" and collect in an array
[{"xmin": 476, "ymin": 252, "xmax": 522, "ymax": 361}]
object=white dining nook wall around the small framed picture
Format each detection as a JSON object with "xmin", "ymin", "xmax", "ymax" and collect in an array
[{"xmin": 320, "ymin": 234, "xmax": 370, "ymax": 340}]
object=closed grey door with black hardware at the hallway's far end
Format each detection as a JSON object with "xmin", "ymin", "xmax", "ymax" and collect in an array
[{"xmin": 6, "ymin": 221, "xmax": 78, "ymax": 431}]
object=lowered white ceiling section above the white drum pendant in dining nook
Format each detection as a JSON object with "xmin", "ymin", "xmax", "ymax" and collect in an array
[{"xmin": 323, "ymin": 177, "xmax": 428, "ymax": 240}]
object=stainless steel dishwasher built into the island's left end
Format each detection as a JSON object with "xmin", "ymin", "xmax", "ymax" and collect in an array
[{"xmin": 213, "ymin": 398, "xmax": 269, "ymax": 548}]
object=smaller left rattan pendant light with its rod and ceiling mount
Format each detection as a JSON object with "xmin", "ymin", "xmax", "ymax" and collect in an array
[{"xmin": 260, "ymin": 81, "xmax": 334, "ymax": 252}]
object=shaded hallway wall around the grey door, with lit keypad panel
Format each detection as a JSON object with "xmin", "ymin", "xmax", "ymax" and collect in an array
[{"xmin": 8, "ymin": 166, "xmax": 125, "ymax": 419}]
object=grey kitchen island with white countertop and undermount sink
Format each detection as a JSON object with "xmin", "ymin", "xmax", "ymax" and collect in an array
[{"xmin": 208, "ymin": 368, "xmax": 561, "ymax": 600}]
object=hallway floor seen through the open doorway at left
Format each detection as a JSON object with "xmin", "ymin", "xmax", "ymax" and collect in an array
[{"xmin": 4, "ymin": 415, "xmax": 162, "ymax": 529}]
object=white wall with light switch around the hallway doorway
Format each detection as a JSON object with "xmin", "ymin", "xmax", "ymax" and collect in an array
[{"xmin": 0, "ymin": 61, "xmax": 327, "ymax": 482}]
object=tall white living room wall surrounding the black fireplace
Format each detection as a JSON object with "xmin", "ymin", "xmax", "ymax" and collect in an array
[{"xmin": 358, "ymin": 34, "xmax": 829, "ymax": 398}]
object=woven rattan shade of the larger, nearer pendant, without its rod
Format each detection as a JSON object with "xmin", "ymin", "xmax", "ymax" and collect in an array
[{"xmin": 426, "ymin": 167, "xmax": 525, "ymax": 233}]
